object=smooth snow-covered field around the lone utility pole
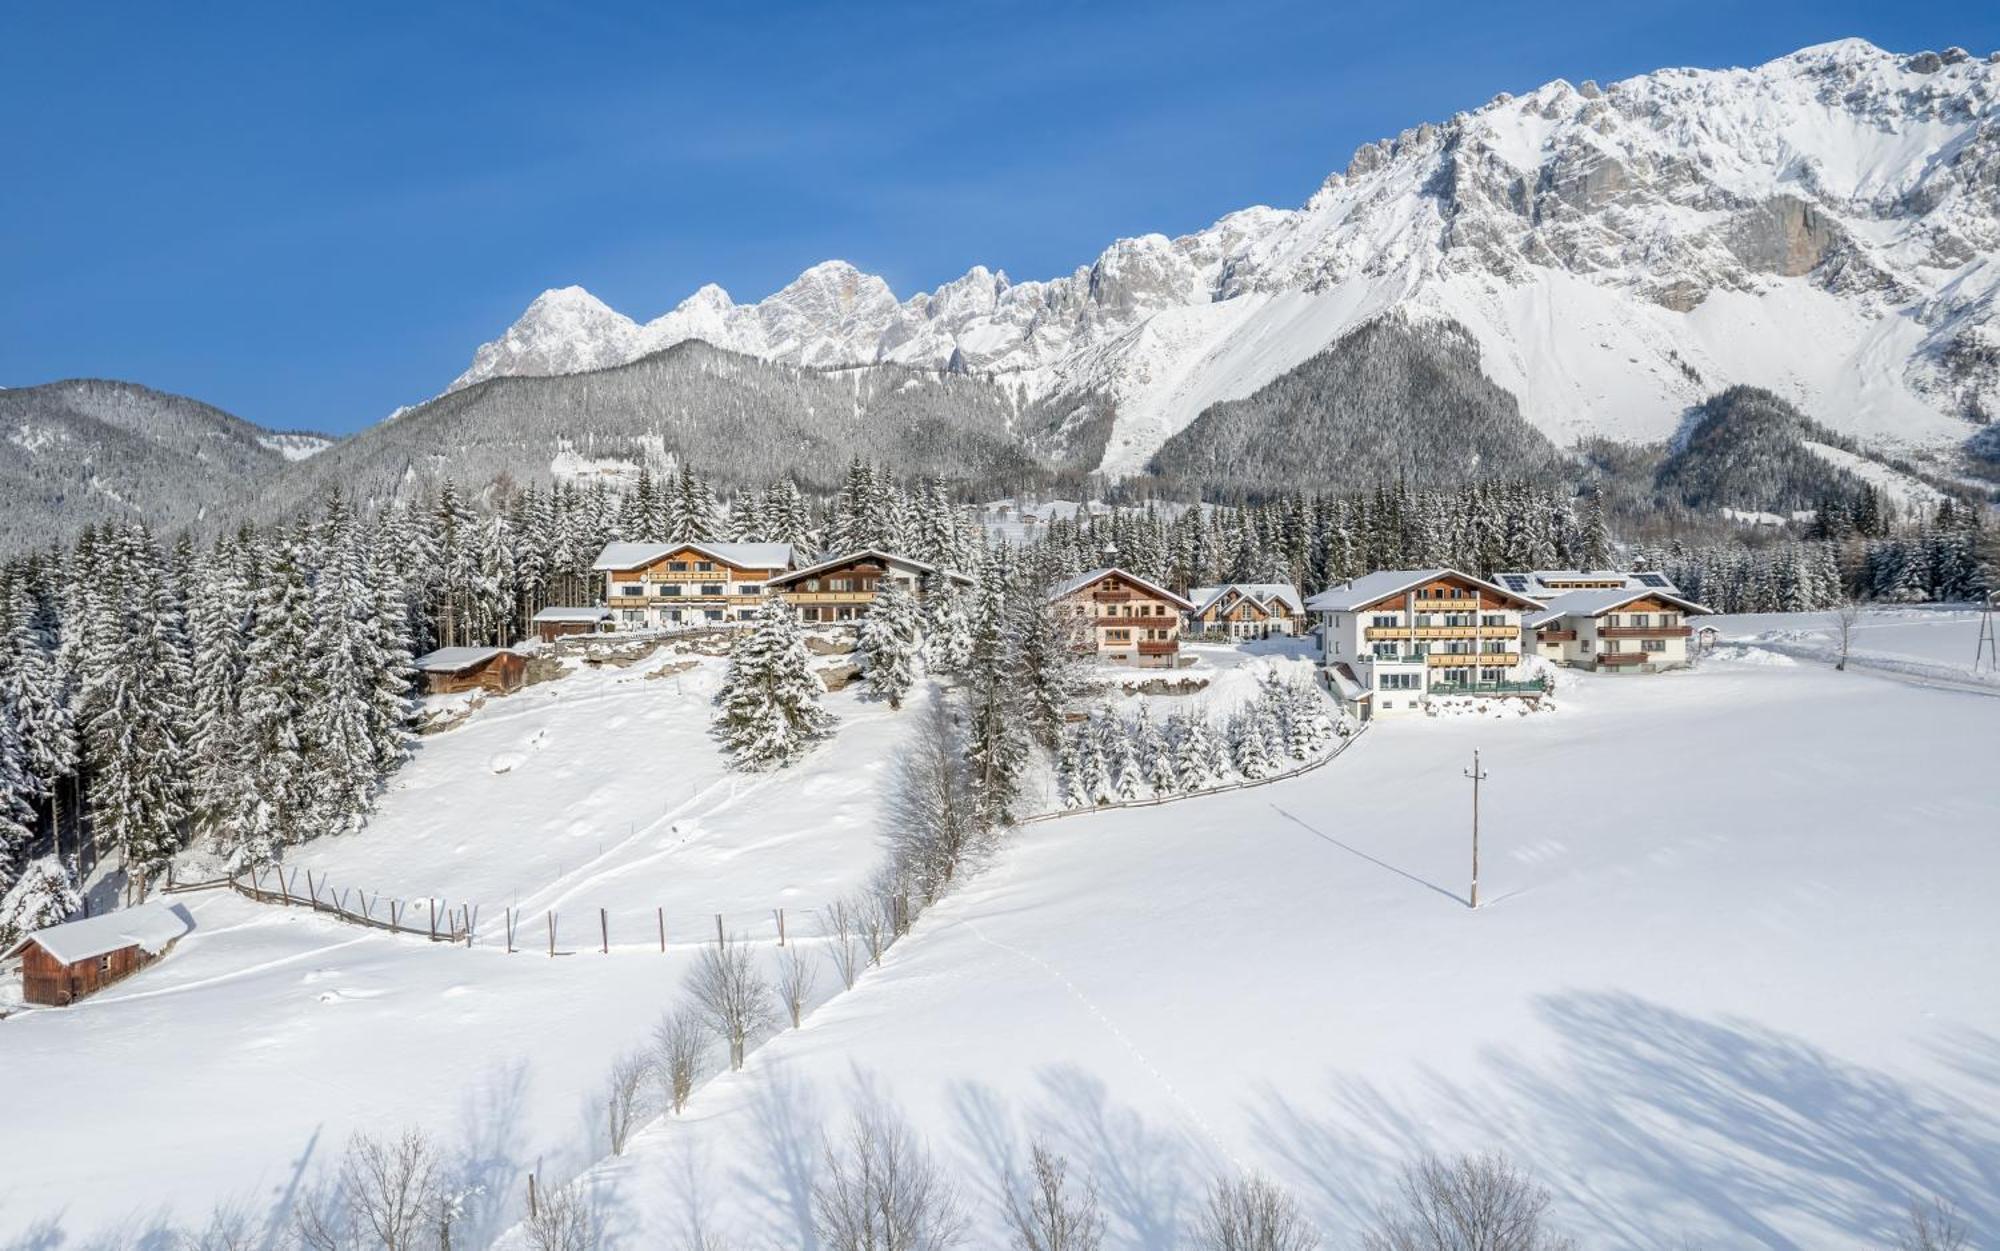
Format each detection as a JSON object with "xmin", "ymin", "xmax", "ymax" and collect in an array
[{"xmin": 532, "ymin": 653, "xmax": 2000, "ymax": 1249}]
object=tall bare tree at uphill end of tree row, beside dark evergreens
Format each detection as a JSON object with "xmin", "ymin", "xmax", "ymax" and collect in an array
[{"xmin": 888, "ymin": 699, "xmax": 992, "ymax": 903}]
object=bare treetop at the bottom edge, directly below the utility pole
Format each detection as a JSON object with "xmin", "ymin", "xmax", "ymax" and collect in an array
[{"xmin": 1362, "ymin": 1155, "xmax": 1576, "ymax": 1251}]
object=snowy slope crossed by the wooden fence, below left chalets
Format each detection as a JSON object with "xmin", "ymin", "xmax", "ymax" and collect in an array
[{"xmin": 0, "ymin": 653, "xmax": 908, "ymax": 1247}]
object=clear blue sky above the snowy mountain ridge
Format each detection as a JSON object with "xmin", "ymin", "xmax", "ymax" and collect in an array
[{"xmin": 0, "ymin": 0, "xmax": 2000, "ymax": 434}]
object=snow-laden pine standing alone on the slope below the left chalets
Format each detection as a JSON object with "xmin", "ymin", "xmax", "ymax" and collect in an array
[{"xmin": 716, "ymin": 600, "xmax": 834, "ymax": 769}]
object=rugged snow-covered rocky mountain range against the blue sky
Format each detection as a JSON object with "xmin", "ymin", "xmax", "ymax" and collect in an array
[{"xmin": 452, "ymin": 40, "xmax": 2000, "ymax": 474}]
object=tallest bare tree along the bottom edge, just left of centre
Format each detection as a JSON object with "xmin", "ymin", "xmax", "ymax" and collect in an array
[{"xmin": 812, "ymin": 1105, "xmax": 966, "ymax": 1251}]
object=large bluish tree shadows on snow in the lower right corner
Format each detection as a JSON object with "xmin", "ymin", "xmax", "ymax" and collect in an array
[{"xmin": 1252, "ymin": 993, "xmax": 2000, "ymax": 1247}]
